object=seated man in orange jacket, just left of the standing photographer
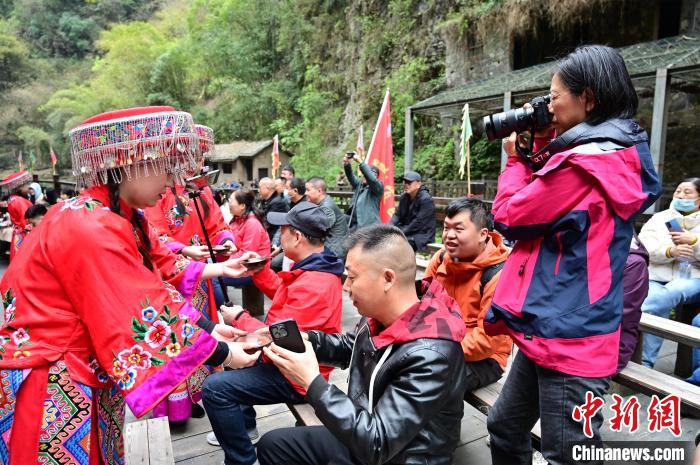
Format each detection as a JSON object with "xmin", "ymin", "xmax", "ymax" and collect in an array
[{"xmin": 425, "ymin": 197, "xmax": 513, "ymax": 392}]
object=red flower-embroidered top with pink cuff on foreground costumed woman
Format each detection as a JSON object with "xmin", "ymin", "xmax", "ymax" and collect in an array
[{"xmin": 0, "ymin": 197, "xmax": 216, "ymax": 416}]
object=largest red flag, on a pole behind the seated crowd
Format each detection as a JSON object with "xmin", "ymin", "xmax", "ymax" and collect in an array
[{"xmin": 367, "ymin": 89, "xmax": 396, "ymax": 223}]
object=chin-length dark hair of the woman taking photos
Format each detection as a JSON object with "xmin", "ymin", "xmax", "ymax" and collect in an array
[{"xmin": 554, "ymin": 45, "xmax": 639, "ymax": 124}]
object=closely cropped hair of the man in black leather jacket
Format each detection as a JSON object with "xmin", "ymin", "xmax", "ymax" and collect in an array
[{"xmin": 344, "ymin": 224, "xmax": 416, "ymax": 286}]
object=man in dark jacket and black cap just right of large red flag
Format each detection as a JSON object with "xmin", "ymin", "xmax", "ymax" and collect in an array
[{"xmin": 390, "ymin": 171, "xmax": 435, "ymax": 252}]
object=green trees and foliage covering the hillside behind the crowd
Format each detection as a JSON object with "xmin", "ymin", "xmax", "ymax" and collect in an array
[{"xmin": 0, "ymin": 0, "xmax": 504, "ymax": 184}]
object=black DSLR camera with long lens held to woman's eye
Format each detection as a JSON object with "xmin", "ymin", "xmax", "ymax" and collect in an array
[{"xmin": 484, "ymin": 95, "xmax": 552, "ymax": 141}]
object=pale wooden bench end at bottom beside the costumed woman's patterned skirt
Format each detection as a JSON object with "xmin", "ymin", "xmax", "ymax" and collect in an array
[{"xmin": 124, "ymin": 417, "xmax": 175, "ymax": 465}]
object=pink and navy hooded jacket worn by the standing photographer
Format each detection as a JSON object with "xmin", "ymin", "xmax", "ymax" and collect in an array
[{"xmin": 484, "ymin": 119, "xmax": 661, "ymax": 377}]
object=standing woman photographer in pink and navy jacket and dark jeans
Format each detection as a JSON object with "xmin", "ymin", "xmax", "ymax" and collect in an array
[{"xmin": 484, "ymin": 45, "xmax": 660, "ymax": 465}]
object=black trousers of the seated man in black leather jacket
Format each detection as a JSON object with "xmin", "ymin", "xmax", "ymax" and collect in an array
[{"xmin": 257, "ymin": 426, "xmax": 364, "ymax": 465}]
